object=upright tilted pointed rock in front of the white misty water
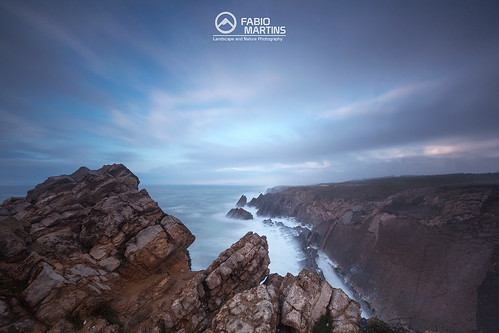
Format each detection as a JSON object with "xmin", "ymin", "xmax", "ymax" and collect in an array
[{"xmin": 204, "ymin": 232, "xmax": 270, "ymax": 311}]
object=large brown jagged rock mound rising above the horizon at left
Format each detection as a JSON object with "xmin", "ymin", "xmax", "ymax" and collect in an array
[{"xmin": 0, "ymin": 164, "xmax": 194, "ymax": 327}]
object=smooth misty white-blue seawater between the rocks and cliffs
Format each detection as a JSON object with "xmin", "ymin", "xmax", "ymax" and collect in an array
[{"xmin": 0, "ymin": 185, "xmax": 369, "ymax": 317}]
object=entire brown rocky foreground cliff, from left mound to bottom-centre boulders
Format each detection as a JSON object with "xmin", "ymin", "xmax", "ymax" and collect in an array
[{"xmin": 0, "ymin": 165, "xmax": 360, "ymax": 333}]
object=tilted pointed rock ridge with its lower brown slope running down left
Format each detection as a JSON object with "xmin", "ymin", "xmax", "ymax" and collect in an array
[{"xmin": 121, "ymin": 233, "xmax": 270, "ymax": 332}]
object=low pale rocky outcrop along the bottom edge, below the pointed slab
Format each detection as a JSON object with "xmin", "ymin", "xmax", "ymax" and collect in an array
[{"xmin": 208, "ymin": 270, "xmax": 361, "ymax": 333}]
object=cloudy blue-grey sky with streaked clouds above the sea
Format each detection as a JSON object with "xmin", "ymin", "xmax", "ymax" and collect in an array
[{"xmin": 0, "ymin": 0, "xmax": 499, "ymax": 186}]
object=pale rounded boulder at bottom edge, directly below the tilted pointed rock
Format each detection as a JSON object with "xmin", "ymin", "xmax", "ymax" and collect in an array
[{"xmin": 210, "ymin": 285, "xmax": 279, "ymax": 333}]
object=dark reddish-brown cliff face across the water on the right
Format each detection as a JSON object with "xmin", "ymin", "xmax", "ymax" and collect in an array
[{"xmin": 250, "ymin": 174, "xmax": 499, "ymax": 332}]
